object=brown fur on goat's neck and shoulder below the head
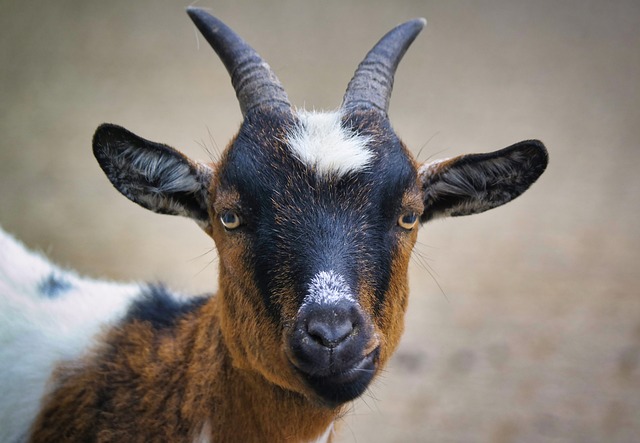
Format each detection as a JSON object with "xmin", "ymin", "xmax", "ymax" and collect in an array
[{"xmin": 31, "ymin": 293, "xmax": 339, "ymax": 442}]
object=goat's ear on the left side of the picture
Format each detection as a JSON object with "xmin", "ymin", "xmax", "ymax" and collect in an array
[{"xmin": 93, "ymin": 124, "xmax": 213, "ymax": 231}]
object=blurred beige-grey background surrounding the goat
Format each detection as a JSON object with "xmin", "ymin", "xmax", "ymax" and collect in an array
[{"xmin": 0, "ymin": 0, "xmax": 640, "ymax": 443}]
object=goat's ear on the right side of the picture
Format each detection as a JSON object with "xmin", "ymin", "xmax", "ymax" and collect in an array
[{"xmin": 418, "ymin": 140, "xmax": 548, "ymax": 222}]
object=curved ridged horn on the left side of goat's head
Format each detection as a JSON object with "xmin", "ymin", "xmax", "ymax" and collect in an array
[{"xmin": 187, "ymin": 7, "xmax": 291, "ymax": 116}]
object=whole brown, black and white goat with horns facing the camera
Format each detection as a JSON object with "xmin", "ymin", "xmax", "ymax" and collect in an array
[{"xmin": 0, "ymin": 7, "xmax": 548, "ymax": 442}]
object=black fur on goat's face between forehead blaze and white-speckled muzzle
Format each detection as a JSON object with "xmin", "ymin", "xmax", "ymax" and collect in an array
[{"xmin": 219, "ymin": 112, "xmax": 416, "ymax": 322}]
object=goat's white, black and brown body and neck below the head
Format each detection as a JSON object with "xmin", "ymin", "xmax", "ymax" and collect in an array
[{"xmin": 0, "ymin": 231, "xmax": 332, "ymax": 442}]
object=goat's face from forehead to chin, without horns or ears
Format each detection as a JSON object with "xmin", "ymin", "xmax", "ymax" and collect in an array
[{"xmin": 212, "ymin": 112, "xmax": 423, "ymax": 403}]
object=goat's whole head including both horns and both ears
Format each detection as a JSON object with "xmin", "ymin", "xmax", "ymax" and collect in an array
[{"xmin": 94, "ymin": 9, "xmax": 547, "ymax": 406}]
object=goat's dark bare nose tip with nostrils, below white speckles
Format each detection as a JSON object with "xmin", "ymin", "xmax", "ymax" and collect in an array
[{"xmin": 306, "ymin": 302, "xmax": 359, "ymax": 349}]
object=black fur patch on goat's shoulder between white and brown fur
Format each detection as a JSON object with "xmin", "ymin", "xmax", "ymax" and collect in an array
[{"xmin": 124, "ymin": 285, "xmax": 209, "ymax": 329}]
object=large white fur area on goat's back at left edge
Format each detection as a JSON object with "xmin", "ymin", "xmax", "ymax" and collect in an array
[{"xmin": 0, "ymin": 229, "xmax": 141, "ymax": 442}]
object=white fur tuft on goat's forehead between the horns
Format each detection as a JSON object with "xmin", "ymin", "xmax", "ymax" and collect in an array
[{"xmin": 287, "ymin": 111, "xmax": 374, "ymax": 177}]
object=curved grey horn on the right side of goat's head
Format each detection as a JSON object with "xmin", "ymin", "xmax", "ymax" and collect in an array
[{"xmin": 342, "ymin": 18, "xmax": 427, "ymax": 114}]
